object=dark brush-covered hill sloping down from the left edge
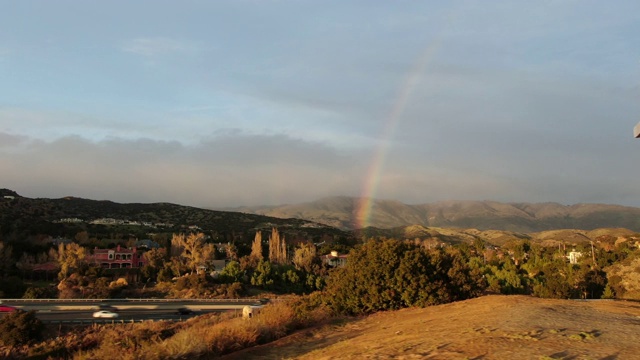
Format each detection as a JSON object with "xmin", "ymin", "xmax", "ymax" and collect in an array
[{"xmin": 0, "ymin": 189, "xmax": 350, "ymax": 245}]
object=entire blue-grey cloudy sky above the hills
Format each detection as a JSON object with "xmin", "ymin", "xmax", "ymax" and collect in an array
[{"xmin": 0, "ymin": 0, "xmax": 640, "ymax": 208}]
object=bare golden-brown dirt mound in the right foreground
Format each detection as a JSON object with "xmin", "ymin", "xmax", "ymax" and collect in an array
[{"xmin": 223, "ymin": 295, "xmax": 640, "ymax": 360}]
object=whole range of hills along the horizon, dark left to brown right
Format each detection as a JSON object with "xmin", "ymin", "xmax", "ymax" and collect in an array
[{"xmin": 5, "ymin": 189, "xmax": 640, "ymax": 246}]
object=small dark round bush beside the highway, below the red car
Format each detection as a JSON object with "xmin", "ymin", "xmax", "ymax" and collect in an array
[{"xmin": 0, "ymin": 310, "xmax": 44, "ymax": 346}]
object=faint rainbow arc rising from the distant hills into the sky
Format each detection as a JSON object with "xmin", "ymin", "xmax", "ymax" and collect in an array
[{"xmin": 354, "ymin": 39, "xmax": 440, "ymax": 229}]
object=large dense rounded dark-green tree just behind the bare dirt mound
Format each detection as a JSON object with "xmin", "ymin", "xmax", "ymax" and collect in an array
[{"xmin": 325, "ymin": 240, "xmax": 483, "ymax": 314}]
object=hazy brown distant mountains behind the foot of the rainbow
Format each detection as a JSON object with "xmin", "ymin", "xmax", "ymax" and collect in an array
[{"xmin": 235, "ymin": 197, "xmax": 640, "ymax": 233}]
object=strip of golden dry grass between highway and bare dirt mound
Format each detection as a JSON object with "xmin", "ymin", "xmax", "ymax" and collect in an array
[{"xmin": 0, "ymin": 298, "xmax": 336, "ymax": 360}]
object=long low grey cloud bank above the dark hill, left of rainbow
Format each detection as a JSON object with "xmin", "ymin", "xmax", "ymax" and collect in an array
[{"xmin": 0, "ymin": 133, "xmax": 363, "ymax": 207}]
